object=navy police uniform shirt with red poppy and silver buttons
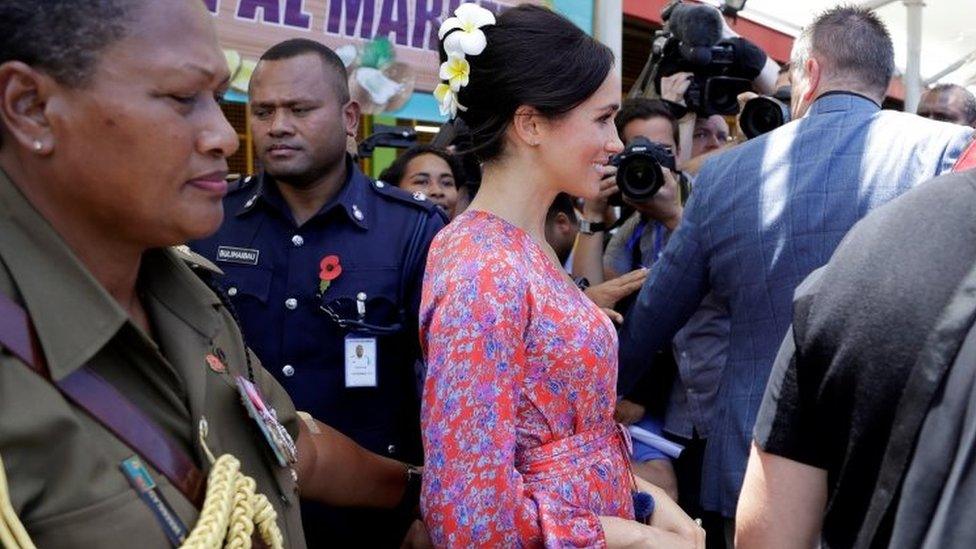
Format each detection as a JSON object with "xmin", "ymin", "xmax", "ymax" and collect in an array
[{"xmin": 191, "ymin": 157, "xmax": 446, "ymax": 463}]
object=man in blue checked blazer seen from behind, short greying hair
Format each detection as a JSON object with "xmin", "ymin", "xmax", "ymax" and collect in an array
[{"xmin": 618, "ymin": 7, "xmax": 972, "ymax": 528}]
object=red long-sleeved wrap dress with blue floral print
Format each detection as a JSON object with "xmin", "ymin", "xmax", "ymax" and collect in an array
[{"xmin": 420, "ymin": 211, "xmax": 634, "ymax": 547}]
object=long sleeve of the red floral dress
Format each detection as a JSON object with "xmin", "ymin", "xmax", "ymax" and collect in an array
[{"xmin": 421, "ymin": 239, "xmax": 603, "ymax": 547}]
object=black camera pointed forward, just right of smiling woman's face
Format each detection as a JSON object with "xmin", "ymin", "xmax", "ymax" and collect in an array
[{"xmin": 610, "ymin": 136, "xmax": 677, "ymax": 206}]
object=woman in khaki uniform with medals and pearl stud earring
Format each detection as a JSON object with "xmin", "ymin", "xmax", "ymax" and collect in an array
[{"xmin": 0, "ymin": 0, "xmax": 410, "ymax": 548}]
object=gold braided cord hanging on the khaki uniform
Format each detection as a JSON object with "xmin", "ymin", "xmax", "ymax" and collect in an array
[{"xmin": 0, "ymin": 419, "xmax": 284, "ymax": 549}]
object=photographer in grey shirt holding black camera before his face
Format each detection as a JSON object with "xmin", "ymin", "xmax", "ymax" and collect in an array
[{"xmin": 574, "ymin": 98, "xmax": 728, "ymax": 539}]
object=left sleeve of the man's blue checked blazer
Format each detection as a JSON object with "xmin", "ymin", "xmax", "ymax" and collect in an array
[{"xmin": 617, "ymin": 180, "xmax": 709, "ymax": 395}]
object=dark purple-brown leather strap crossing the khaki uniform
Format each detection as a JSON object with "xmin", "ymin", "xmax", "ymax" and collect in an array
[{"xmin": 0, "ymin": 293, "xmax": 206, "ymax": 509}]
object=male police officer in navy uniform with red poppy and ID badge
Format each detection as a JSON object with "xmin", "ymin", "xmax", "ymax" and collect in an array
[{"xmin": 193, "ymin": 39, "xmax": 445, "ymax": 547}]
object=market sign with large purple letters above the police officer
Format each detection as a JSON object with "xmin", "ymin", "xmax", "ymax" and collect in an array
[{"xmin": 204, "ymin": 0, "xmax": 546, "ymax": 91}]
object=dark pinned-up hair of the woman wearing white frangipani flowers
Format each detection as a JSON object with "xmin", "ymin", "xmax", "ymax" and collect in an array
[{"xmin": 441, "ymin": 5, "xmax": 613, "ymax": 162}]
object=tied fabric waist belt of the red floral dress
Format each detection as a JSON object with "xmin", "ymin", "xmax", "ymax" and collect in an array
[{"xmin": 515, "ymin": 422, "xmax": 630, "ymax": 482}]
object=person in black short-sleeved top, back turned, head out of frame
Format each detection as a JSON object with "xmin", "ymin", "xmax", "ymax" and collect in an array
[{"xmin": 736, "ymin": 170, "xmax": 976, "ymax": 547}]
